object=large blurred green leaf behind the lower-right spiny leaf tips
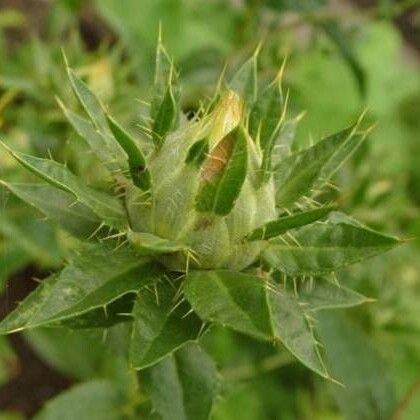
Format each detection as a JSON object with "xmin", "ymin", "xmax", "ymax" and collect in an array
[{"xmin": 318, "ymin": 312, "xmax": 396, "ymax": 420}]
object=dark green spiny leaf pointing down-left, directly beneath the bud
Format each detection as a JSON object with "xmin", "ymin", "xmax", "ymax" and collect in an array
[{"xmin": 130, "ymin": 282, "xmax": 202, "ymax": 369}]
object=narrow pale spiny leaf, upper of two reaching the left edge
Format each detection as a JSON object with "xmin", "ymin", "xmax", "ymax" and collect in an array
[{"xmin": 2, "ymin": 143, "xmax": 126, "ymax": 227}]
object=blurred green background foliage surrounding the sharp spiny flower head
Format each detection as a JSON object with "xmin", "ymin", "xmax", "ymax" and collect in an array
[{"xmin": 0, "ymin": 0, "xmax": 420, "ymax": 420}]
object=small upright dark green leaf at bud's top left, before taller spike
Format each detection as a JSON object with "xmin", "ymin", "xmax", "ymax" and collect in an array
[{"xmin": 152, "ymin": 84, "xmax": 178, "ymax": 147}]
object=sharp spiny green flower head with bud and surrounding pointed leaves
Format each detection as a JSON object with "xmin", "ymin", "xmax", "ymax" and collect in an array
[{"xmin": 0, "ymin": 43, "xmax": 399, "ymax": 419}]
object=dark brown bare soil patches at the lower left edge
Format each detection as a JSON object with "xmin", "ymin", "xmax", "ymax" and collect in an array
[{"xmin": 0, "ymin": 266, "xmax": 72, "ymax": 418}]
